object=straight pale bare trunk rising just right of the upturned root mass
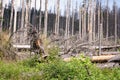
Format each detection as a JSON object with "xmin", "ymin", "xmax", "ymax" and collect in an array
[{"xmin": 44, "ymin": 0, "xmax": 48, "ymax": 38}]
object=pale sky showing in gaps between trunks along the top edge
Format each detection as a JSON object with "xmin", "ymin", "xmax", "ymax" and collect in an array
[{"xmin": 3, "ymin": 0, "xmax": 120, "ymax": 15}]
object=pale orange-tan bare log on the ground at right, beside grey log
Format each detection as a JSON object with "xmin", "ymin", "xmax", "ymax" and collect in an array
[{"xmin": 91, "ymin": 55, "xmax": 115, "ymax": 62}]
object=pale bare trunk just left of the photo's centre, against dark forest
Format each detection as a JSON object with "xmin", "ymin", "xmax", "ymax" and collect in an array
[{"xmin": 55, "ymin": 0, "xmax": 60, "ymax": 35}]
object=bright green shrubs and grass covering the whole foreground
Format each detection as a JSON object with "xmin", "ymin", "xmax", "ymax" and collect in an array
[{"xmin": 0, "ymin": 48, "xmax": 120, "ymax": 80}]
